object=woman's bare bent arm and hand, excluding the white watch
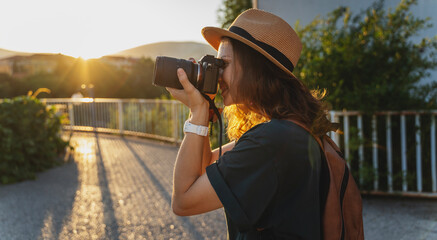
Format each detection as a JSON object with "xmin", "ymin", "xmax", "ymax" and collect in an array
[{"xmin": 168, "ymin": 69, "xmax": 223, "ymax": 216}]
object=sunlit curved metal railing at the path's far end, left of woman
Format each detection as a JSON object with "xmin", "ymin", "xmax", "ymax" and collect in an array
[{"xmin": 42, "ymin": 98, "xmax": 188, "ymax": 143}]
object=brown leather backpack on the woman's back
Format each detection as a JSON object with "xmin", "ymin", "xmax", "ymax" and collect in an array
[{"xmin": 292, "ymin": 121, "xmax": 364, "ymax": 240}]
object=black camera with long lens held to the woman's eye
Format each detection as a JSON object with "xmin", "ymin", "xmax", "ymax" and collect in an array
[{"xmin": 153, "ymin": 55, "xmax": 225, "ymax": 94}]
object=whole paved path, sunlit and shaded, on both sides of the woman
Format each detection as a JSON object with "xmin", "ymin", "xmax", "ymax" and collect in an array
[{"xmin": 0, "ymin": 133, "xmax": 437, "ymax": 240}]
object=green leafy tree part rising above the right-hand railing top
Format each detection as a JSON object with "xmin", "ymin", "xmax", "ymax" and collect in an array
[{"xmin": 295, "ymin": 0, "xmax": 437, "ymax": 111}]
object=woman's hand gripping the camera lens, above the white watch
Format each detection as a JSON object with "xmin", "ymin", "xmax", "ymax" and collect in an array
[{"xmin": 166, "ymin": 68, "xmax": 209, "ymax": 115}]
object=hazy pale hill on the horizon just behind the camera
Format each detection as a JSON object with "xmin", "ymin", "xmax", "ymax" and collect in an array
[{"xmin": 108, "ymin": 42, "xmax": 216, "ymax": 60}]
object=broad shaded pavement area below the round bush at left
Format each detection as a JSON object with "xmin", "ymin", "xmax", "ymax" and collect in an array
[{"xmin": 0, "ymin": 148, "xmax": 79, "ymax": 239}]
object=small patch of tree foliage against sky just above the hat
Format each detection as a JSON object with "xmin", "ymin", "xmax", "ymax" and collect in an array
[{"xmin": 217, "ymin": 0, "xmax": 252, "ymax": 28}]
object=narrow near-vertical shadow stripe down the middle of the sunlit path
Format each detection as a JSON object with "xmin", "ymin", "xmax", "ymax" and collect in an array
[{"xmin": 95, "ymin": 133, "xmax": 120, "ymax": 239}]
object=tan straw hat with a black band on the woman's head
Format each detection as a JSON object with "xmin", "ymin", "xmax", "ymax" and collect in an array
[{"xmin": 202, "ymin": 9, "xmax": 302, "ymax": 77}]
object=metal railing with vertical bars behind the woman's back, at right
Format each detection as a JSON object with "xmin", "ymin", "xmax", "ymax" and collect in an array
[{"xmin": 330, "ymin": 111, "xmax": 437, "ymax": 197}]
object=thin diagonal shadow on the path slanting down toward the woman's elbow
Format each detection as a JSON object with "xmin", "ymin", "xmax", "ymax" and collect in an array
[{"xmin": 123, "ymin": 138, "xmax": 204, "ymax": 239}]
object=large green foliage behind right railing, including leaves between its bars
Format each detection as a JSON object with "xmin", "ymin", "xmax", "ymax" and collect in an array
[{"xmin": 295, "ymin": 0, "xmax": 437, "ymax": 190}]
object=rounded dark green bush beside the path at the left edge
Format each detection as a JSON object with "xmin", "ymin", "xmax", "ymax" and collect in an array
[{"xmin": 0, "ymin": 96, "xmax": 69, "ymax": 184}]
